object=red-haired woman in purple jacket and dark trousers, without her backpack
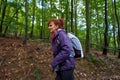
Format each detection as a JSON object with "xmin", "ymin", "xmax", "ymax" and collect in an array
[{"xmin": 48, "ymin": 19, "xmax": 75, "ymax": 80}]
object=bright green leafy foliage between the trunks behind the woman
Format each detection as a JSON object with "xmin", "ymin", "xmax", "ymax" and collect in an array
[{"xmin": 0, "ymin": 0, "xmax": 120, "ymax": 54}]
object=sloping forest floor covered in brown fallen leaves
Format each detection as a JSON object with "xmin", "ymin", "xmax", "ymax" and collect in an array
[{"xmin": 0, "ymin": 37, "xmax": 120, "ymax": 80}]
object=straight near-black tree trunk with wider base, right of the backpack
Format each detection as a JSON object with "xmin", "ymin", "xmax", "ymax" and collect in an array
[{"xmin": 103, "ymin": 0, "xmax": 108, "ymax": 55}]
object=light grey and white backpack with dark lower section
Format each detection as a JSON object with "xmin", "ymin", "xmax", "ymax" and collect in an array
[{"xmin": 67, "ymin": 33, "xmax": 84, "ymax": 58}]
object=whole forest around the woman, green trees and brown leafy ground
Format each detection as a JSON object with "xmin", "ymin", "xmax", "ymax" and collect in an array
[{"xmin": 0, "ymin": 0, "xmax": 120, "ymax": 80}]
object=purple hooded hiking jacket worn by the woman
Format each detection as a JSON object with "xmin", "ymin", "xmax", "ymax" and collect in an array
[{"xmin": 51, "ymin": 29, "xmax": 75, "ymax": 71}]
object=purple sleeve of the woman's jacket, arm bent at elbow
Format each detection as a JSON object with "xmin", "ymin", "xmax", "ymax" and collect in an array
[{"xmin": 51, "ymin": 31, "xmax": 71, "ymax": 68}]
